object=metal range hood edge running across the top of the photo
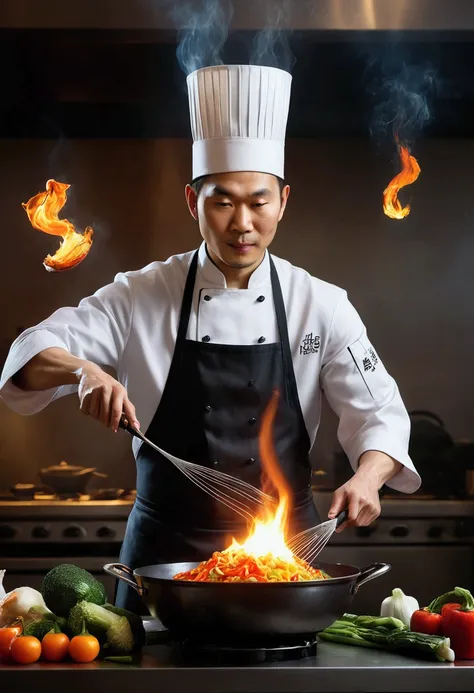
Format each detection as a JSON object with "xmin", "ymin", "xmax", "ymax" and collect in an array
[{"xmin": 0, "ymin": 0, "xmax": 474, "ymax": 31}]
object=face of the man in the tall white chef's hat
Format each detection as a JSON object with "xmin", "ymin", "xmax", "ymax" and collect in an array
[{"xmin": 186, "ymin": 171, "xmax": 290, "ymax": 270}]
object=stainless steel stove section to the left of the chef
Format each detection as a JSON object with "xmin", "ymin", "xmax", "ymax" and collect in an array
[{"xmin": 0, "ymin": 489, "xmax": 135, "ymax": 600}]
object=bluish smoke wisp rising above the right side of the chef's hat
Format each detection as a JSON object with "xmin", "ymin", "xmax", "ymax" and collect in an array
[{"xmin": 250, "ymin": 0, "xmax": 295, "ymax": 72}]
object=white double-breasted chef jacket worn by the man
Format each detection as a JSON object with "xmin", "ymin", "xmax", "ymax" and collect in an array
[{"xmin": 0, "ymin": 243, "xmax": 420, "ymax": 493}]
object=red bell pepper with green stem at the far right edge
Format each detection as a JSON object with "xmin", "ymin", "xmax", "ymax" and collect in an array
[{"xmin": 430, "ymin": 587, "xmax": 474, "ymax": 659}]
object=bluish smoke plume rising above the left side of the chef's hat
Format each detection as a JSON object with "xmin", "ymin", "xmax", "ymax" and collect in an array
[{"xmin": 165, "ymin": 0, "xmax": 234, "ymax": 75}]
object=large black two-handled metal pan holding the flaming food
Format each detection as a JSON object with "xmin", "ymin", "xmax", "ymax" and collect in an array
[{"xmin": 104, "ymin": 563, "xmax": 391, "ymax": 643}]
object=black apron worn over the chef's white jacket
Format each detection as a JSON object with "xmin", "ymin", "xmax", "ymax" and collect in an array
[{"xmin": 116, "ymin": 252, "xmax": 319, "ymax": 613}]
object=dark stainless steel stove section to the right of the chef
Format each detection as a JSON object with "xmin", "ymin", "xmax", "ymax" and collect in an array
[{"xmin": 316, "ymin": 494, "xmax": 474, "ymax": 613}]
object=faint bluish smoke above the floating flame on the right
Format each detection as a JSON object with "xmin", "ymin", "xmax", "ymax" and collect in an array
[{"xmin": 370, "ymin": 63, "xmax": 438, "ymax": 148}]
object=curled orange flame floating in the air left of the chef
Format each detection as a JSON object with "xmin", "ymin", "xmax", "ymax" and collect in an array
[{"xmin": 22, "ymin": 179, "xmax": 94, "ymax": 272}]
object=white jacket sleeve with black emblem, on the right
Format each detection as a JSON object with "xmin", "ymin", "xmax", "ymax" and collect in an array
[{"xmin": 321, "ymin": 294, "xmax": 421, "ymax": 493}]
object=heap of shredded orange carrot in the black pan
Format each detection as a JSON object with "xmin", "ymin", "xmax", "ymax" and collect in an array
[{"xmin": 174, "ymin": 548, "xmax": 330, "ymax": 582}]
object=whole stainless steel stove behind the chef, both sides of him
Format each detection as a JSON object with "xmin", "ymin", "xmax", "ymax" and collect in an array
[{"xmin": 0, "ymin": 489, "xmax": 474, "ymax": 613}]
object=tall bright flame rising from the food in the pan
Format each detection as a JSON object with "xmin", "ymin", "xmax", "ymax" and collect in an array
[{"xmin": 228, "ymin": 390, "xmax": 294, "ymax": 562}]
